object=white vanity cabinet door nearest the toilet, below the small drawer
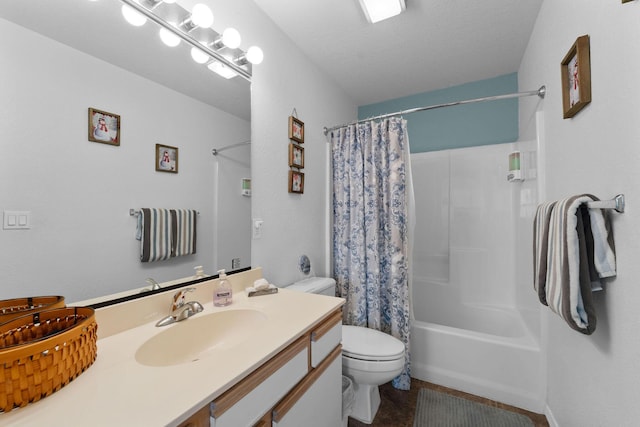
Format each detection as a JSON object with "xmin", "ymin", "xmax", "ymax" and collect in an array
[{"xmin": 273, "ymin": 346, "xmax": 342, "ymax": 427}]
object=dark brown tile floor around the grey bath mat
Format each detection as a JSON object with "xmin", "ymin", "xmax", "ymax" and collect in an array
[{"xmin": 349, "ymin": 379, "xmax": 549, "ymax": 427}]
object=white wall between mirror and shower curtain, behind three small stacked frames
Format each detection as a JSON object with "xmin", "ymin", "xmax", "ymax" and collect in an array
[{"xmin": 251, "ymin": 5, "xmax": 357, "ymax": 285}]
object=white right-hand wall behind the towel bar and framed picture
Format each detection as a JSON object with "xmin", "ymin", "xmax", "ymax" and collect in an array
[{"xmin": 519, "ymin": 0, "xmax": 640, "ymax": 426}]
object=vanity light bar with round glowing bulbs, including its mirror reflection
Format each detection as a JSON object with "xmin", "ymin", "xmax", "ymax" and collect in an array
[{"xmin": 120, "ymin": 0, "xmax": 264, "ymax": 81}]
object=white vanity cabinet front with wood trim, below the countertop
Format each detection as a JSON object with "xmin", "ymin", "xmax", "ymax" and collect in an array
[{"xmin": 210, "ymin": 310, "xmax": 342, "ymax": 427}]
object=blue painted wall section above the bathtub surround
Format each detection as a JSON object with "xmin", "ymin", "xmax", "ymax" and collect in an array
[{"xmin": 358, "ymin": 73, "xmax": 518, "ymax": 153}]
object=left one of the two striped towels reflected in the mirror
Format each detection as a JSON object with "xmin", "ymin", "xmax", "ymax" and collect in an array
[{"xmin": 139, "ymin": 208, "xmax": 173, "ymax": 262}]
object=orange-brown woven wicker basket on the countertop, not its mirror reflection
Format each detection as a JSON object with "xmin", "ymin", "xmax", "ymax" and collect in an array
[{"xmin": 0, "ymin": 307, "xmax": 98, "ymax": 412}]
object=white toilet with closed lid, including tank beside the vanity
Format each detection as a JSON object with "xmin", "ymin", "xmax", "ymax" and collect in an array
[{"xmin": 287, "ymin": 277, "xmax": 404, "ymax": 424}]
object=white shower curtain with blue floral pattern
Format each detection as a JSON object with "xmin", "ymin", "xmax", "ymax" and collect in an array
[{"xmin": 331, "ymin": 118, "xmax": 411, "ymax": 390}]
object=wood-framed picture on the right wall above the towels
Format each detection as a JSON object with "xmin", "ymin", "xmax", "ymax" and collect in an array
[{"xmin": 561, "ymin": 35, "xmax": 591, "ymax": 119}]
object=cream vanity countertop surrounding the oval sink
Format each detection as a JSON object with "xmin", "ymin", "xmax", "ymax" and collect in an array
[{"xmin": 0, "ymin": 289, "xmax": 343, "ymax": 427}]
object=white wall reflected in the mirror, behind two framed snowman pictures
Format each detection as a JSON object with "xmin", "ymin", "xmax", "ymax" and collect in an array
[{"xmin": 0, "ymin": 20, "xmax": 250, "ymax": 301}]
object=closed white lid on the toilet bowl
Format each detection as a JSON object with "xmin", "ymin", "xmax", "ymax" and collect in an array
[{"xmin": 342, "ymin": 325, "xmax": 404, "ymax": 360}]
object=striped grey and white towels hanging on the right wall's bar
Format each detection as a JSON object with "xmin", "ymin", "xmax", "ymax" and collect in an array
[{"xmin": 534, "ymin": 194, "xmax": 616, "ymax": 335}]
